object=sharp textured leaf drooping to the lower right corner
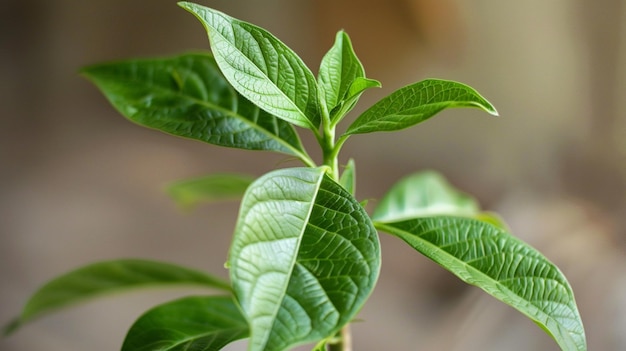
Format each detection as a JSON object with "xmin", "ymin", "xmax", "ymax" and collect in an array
[{"xmin": 375, "ymin": 217, "xmax": 587, "ymax": 351}]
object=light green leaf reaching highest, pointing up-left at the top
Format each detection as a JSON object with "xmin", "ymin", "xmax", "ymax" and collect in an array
[{"xmin": 179, "ymin": 2, "xmax": 320, "ymax": 130}]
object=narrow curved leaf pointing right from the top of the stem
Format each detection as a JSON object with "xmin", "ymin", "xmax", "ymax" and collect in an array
[{"xmin": 346, "ymin": 79, "xmax": 498, "ymax": 135}]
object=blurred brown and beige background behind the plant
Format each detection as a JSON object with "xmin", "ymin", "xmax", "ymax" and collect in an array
[{"xmin": 0, "ymin": 0, "xmax": 626, "ymax": 351}]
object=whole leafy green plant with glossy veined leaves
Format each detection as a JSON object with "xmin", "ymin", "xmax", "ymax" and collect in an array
[{"xmin": 6, "ymin": 2, "xmax": 586, "ymax": 351}]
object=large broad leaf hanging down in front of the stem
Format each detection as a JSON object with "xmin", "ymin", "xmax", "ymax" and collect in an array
[{"xmin": 229, "ymin": 168, "xmax": 380, "ymax": 351}]
